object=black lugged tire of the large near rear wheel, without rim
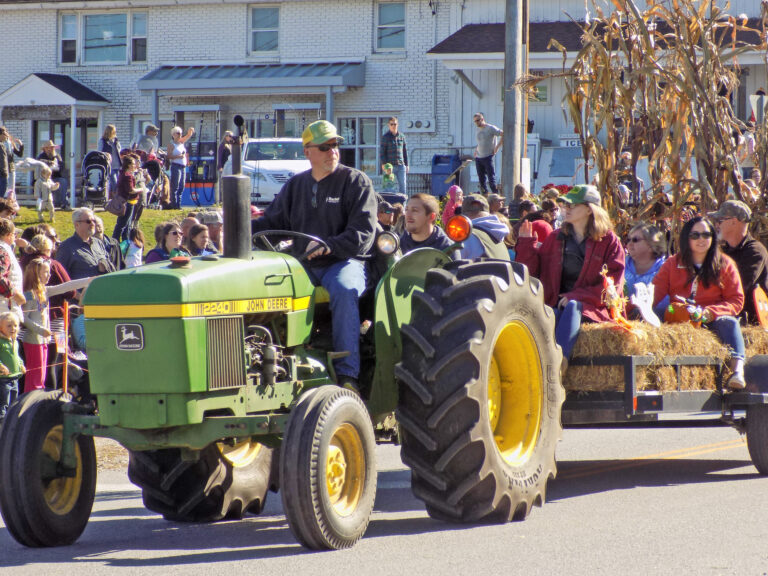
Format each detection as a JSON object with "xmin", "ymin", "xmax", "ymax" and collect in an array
[{"xmin": 395, "ymin": 260, "xmax": 564, "ymax": 522}]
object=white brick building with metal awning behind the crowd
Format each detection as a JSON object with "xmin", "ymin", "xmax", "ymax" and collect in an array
[{"xmin": 0, "ymin": 0, "xmax": 766, "ymax": 197}]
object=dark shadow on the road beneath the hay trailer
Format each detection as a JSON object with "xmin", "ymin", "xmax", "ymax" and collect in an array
[{"xmin": 547, "ymin": 458, "xmax": 762, "ymax": 502}]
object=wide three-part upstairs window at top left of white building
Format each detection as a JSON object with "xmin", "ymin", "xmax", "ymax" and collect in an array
[{"xmin": 59, "ymin": 12, "xmax": 147, "ymax": 65}]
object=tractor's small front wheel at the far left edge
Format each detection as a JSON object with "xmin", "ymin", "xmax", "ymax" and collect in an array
[{"xmin": 0, "ymin": 391, "xmax": 96, "ymax": 547}]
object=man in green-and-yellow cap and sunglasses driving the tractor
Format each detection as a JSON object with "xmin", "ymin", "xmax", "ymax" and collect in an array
[{"xmin": 251, "ymin": 120, "xmax": 377, "ymax": 389}]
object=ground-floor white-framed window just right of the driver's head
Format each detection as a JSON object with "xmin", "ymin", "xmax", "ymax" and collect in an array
[{"xmin": 336, "ymin": 114, "xmax": 392, "ymax": 176}]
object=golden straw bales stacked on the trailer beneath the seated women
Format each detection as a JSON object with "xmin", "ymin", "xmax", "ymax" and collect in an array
[{"xmin": 563, "ymin": 322, "xmax": 728, "ymax": 392}]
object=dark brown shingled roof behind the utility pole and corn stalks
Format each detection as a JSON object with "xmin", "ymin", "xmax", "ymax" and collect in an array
[{"xmin": 428, "ymin": 18, "xmax": 760, "ymax": 54}]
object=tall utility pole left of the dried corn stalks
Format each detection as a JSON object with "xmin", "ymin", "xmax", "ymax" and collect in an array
[{"xmin": 501, "ymin": 0, "xmax": 527, "ymax": 198}]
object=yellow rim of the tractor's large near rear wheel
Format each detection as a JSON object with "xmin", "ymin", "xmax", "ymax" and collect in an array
[{"xmin": 487, "ymin": 321, "xmax": 544, "ymax": 466}]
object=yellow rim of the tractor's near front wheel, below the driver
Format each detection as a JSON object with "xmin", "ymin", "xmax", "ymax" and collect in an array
[{"xmin": 325, "ymin": 424, "xmax": 365, "ymax": 516}]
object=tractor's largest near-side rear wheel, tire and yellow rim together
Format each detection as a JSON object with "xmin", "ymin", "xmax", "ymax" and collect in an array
[{"xmin": 395, "ymin": 261, "xmax": 565, "ymax": 522}]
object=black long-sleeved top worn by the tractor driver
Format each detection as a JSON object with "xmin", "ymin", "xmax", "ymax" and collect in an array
[{"xmin": 251, "ymin": 164, "xmax": 378, "ymax": 266}]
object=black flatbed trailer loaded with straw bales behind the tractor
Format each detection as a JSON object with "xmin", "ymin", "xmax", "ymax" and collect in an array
[{"xmin": 562, "ymin": 323, "xmax": 768, "ymax": 474}]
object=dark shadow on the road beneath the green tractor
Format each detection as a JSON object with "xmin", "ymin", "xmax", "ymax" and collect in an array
[{"xmin": 0, "ymin": 470, "xmax": 438, "ymax": 567}]
